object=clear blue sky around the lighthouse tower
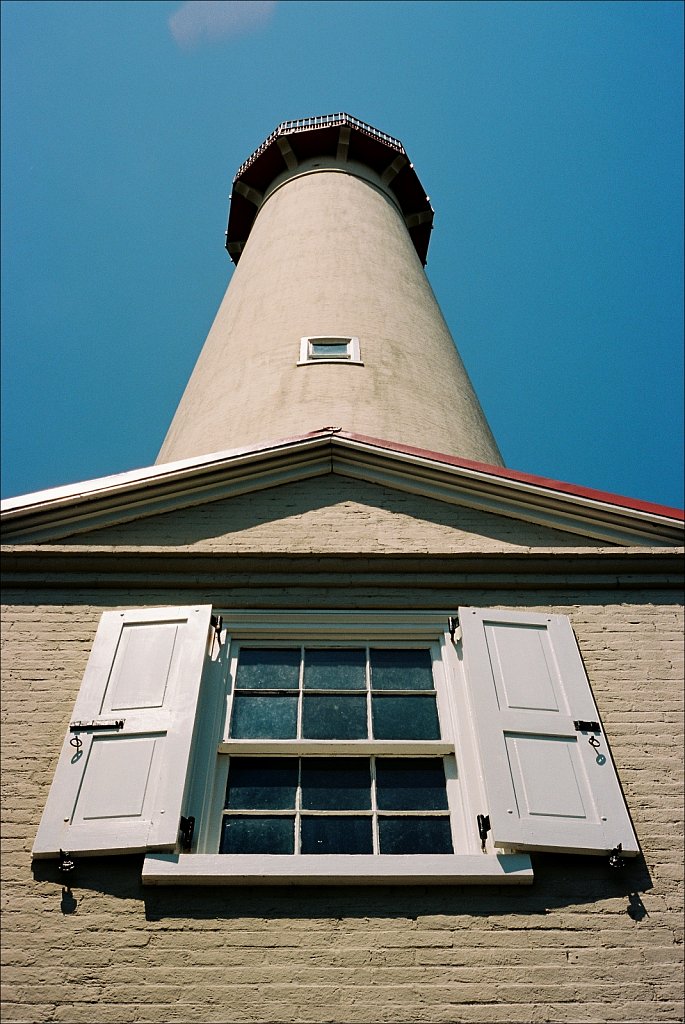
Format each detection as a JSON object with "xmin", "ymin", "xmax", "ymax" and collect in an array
[{"xmin": 1, "ymin": 0, "xmax": 683, "ymax": 507}]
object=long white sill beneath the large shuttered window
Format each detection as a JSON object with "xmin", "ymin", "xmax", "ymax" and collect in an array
[{"xmin": 142, "ymin": 853, "xmax": 532, "ymax": 886}]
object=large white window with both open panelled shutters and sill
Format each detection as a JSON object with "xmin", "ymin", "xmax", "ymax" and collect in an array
[{"xmin": 34, "ymin": 607, "xmax": 638, "ymax": 884}]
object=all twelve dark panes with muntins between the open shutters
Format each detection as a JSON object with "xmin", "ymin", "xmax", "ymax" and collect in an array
[{"xmin": 219, "ymin": 644, "xmax": 454, "ymax": 854}]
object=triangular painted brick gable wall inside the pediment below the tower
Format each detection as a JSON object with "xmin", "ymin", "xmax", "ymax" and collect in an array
[{"xmin": 40, "ymin": 473, "xmax": 601, "ymax": 554}]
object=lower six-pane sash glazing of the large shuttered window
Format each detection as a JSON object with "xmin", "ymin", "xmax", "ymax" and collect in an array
[{"xmin": 219, "ymin": 756, "xmax": 454, "ymax": 855}]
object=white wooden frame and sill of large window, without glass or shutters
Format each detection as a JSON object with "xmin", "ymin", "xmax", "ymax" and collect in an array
[{"xmin": 142, "ymin": 609, "xmax": 532, "ymax": 885}]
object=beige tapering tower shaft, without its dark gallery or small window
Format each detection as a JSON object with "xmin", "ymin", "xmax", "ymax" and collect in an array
[{"xmin": 157, "ymin": 168, "xmax": 502, "ymax": 465}]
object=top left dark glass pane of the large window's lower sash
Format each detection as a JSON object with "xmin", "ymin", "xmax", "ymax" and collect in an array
[{"xmin": 224, "ymin": 758, "xmax": 298, "ymax": 811}]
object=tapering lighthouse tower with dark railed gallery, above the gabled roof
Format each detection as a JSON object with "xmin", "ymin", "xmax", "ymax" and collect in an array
[{"xmin": 157, "ymin": 114, "xmax": 502, "ymax": 466}]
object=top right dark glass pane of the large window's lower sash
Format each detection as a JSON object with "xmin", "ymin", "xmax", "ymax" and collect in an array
[{"xmin": 376, "ymin": 758, "xmax": 447, "ymax": 811}]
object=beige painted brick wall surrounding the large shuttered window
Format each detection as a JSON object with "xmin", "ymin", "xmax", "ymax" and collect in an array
[{"xmin": 2, "ymin": 591, "xmax": 683, "ymax": 1024}]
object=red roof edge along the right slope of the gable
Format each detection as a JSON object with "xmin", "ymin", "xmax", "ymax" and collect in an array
[{"xmin": 331, "ymin": 430, "xmax": 685, "ymax": 521}]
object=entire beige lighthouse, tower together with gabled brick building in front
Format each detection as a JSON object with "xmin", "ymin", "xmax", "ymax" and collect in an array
[{"xmin": 0, "ymin": 114, "xmax": 684, "ymax": 1024}]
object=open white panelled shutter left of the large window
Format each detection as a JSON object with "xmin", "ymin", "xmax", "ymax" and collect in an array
[{"xmin": 33, "ymin": 605, "xmax": 211, "ymax": 857}]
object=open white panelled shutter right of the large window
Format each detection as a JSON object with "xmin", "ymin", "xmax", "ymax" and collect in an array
[{"xmin": 460, "ymin": 608, "xmax": 639, "ymax": 855}]
